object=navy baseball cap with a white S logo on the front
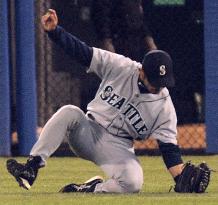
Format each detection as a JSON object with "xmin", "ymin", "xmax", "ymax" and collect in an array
[{"xmin": 142, "ymin": 50, "xmax": 175, "ymax": 88}]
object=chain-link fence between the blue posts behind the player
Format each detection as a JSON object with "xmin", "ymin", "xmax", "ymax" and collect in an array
[{"xmin": 32, "ymin": 0, "xmax": 206, "ymax": 155}]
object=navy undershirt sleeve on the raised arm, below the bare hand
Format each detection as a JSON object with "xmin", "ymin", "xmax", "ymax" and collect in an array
[{"xmin": 47, "ymin": 26, "xmax": 93, "ymax": 67}]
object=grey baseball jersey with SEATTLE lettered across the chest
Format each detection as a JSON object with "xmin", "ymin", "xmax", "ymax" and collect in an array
[{"xmin": 87, "ymin": 48, "xmax": 177, "ymax": 144}]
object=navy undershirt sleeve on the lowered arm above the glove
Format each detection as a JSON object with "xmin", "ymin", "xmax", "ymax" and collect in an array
[{"xmin": 158, "ymin": 141, "xmax": 183, "ymax": 169}]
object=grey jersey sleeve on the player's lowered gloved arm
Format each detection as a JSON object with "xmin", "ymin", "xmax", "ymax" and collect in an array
[{"xmin": 151, "ymin": 96, "xmax": 177, "ymax": 145}]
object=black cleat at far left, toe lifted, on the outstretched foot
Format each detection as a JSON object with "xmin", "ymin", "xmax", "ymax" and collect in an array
[{"xmin": 7, "ymin": 156, "xmax": 42, "ymax": 190}]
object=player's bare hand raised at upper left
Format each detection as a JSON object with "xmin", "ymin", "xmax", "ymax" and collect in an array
[{"xmin": 41, "ymin": 9, "xmax": 58, "ymax": 31}]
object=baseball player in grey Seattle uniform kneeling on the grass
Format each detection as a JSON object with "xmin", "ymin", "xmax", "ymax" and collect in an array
[{"xmin": 7, "ymin": 9, "xmax": 209, "ymax": 193}]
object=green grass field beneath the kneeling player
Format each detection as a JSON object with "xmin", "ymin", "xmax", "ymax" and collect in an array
[{"xmin": 0, "ymin": 156, "xmax": 218, "ymax": 205}]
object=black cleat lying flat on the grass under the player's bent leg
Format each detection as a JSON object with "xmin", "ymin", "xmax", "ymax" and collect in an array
[{"xmin": 59, "ymin": 176, "xmax": 103, "ymax": 193}]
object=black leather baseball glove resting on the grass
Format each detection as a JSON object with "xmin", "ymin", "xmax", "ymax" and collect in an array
[{"xmin": 174, "ymin": 162, "xmax": 211, "ymax": 193}]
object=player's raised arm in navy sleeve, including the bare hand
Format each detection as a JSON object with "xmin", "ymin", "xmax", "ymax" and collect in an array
[{"xmin": 41, "ymin": 9, "xmax": 93, "ymax": 67}]
